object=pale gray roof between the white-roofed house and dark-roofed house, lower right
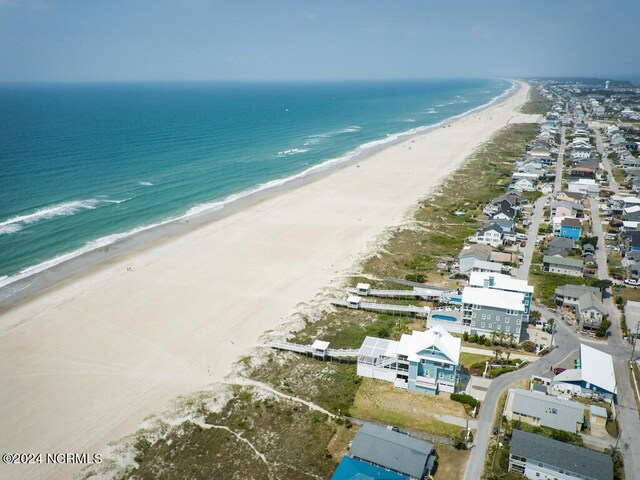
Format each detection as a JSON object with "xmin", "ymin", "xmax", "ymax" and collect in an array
[{"xmin": 510, "ymin": 388, "xmax": 584, "ymax": 433}]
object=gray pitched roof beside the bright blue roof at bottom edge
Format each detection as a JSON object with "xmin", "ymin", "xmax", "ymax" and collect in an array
[{"xmin": 350, "ymin": 423, "xmax": 433, "ymax": 478}]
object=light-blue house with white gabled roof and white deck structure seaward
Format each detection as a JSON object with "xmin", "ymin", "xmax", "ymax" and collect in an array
[{"xmin": 357, "ymin": 326, "xmax": 462, "ymax": 394}]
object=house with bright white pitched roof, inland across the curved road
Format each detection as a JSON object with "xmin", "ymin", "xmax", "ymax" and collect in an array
[{"xmin": 551, "ymin": 343, "xmax": 617, "ymax": 403}]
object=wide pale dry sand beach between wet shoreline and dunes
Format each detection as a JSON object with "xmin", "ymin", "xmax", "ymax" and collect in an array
[{"xmin": 0, "ymin": 80, "xmax": 536, "ymax": 479}]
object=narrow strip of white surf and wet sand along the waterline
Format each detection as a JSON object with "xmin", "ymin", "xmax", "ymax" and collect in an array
[{"xmin": 0, "ymin": 79, "xmax": 522, "ymax": 310}]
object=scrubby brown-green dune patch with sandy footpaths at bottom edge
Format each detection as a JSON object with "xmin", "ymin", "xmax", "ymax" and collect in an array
[{"xmin": 130, "ymin": 389, "xmax": 340, "ymax": 480}]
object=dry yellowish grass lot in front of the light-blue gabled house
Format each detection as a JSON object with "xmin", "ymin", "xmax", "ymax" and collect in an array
[{"xmin": 351, "ymin": 378, "xmax": 467, "ymax": 438}]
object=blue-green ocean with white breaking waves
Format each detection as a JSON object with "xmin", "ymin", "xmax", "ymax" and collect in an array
[{"xmin": 0, "ymin": 79, "xmax": 511, "ymax": 287}]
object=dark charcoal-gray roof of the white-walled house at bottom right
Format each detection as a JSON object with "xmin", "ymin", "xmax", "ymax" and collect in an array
[{"xmin": 510, "ymin": 430, "xmax": 613, "ymax": 480}]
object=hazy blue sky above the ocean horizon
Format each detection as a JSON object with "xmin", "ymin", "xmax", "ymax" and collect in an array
[{"xmin": 0, "ymin": 0, "xmax": 640, "ymax": 82}]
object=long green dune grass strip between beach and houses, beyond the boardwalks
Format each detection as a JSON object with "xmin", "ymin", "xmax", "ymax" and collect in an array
[{"xmin": 363, "ymin": 124, "xmax": 538, "ymax": 282}]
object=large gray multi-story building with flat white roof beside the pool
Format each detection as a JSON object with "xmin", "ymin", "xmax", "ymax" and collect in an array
[{"xmin": 462, "ymin": 286, "xmax": 528, "ymax": 342}]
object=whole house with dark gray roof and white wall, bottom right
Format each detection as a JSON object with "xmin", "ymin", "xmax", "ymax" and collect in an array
[{"xmin": 509, "ymin": 429, "xmax": 613, "ymax": 480}]
